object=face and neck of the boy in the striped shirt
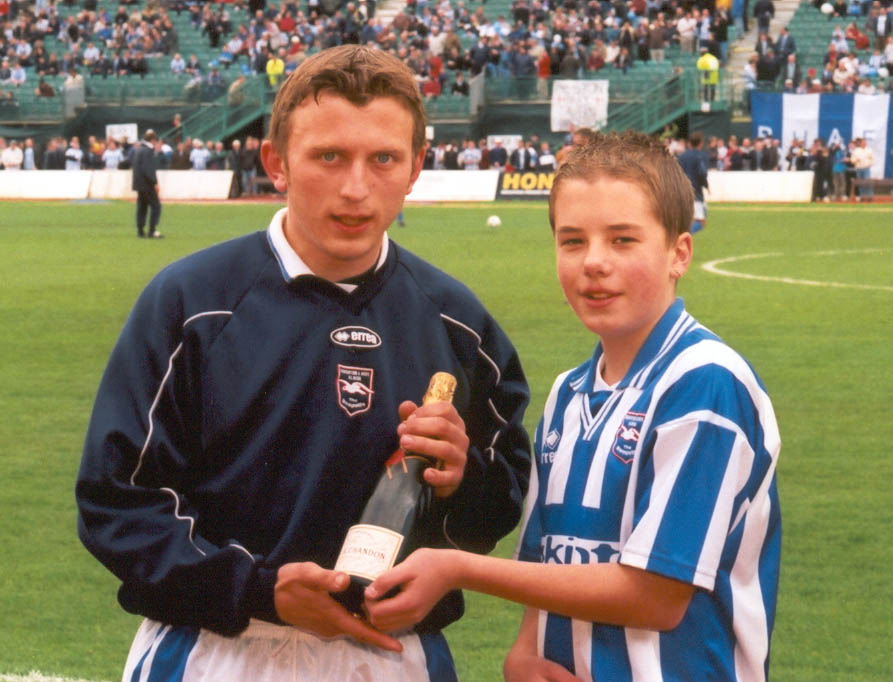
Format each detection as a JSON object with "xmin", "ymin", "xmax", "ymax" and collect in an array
[{"xmin": 555, "ymin": 176, "xmax": 692, "ymax": 383}]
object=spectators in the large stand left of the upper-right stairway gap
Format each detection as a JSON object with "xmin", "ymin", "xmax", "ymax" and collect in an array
[{"xmin": 0, "ymin": 0, "xmax": 731, "ymax": 102}]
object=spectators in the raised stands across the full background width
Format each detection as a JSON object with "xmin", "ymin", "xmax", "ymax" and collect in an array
[{"xmin": 0, "ymin": 0, "xmax": 893, "ymax": 115}]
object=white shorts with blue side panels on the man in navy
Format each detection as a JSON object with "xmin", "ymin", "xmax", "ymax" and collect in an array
[{"xmin": 122, "ymin": 619, "xmax": 456, "ymax": 682}]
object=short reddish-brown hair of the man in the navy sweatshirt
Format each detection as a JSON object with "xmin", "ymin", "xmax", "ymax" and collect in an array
[{"xmin": 270, "ymin": 45, "xmax": 425, "ymax": 159}]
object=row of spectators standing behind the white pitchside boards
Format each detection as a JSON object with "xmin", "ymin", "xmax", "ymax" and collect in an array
[{"xmin": 0, "ymin": 126, "xmax": 873, "ymax": 202}]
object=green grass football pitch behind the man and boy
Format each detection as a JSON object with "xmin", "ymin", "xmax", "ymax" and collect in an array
[{"xmin": 0, "ymin": 202, "xmax": 893, "ymax": 682}]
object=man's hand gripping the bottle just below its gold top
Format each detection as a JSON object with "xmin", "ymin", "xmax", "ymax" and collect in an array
[{"xmin": 397, "ymin": 400, "xmax": 469, "ymax": 497}]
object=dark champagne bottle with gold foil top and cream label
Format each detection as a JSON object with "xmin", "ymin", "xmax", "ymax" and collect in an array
[{"xmin": 332, "ymin": 372, "xmax": 456, "ymax": 613}]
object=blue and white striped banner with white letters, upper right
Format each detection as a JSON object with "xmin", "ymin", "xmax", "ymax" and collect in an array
[{"xmin": 751, "ymin": 92, "xmax": 893, "ymax": 178}]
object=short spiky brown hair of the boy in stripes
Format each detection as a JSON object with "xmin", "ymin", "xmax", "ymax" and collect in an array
[{"xmin": 549, "ymin": 130, "xmax": 695, "ymax": 243}]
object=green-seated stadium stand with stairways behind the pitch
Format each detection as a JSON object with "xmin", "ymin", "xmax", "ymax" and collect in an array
[{"xmin": 8, "ymin": 0, "xmax": 893, "ymax": 194}]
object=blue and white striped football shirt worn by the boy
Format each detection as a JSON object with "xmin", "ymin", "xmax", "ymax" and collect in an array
[{"xmin": 516, "ymin": 299, "xmax": 781, "ymax": 682}]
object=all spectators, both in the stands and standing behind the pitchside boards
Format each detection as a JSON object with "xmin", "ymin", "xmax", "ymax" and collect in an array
[{"xmin": 0, "ymin": 0, "xmax": 893, "ymax": 199}]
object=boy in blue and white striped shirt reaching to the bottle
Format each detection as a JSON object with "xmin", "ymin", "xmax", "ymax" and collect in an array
[{"xmin": 366, "ymin": 133, "xmax": 781, "ymax": 682}]
